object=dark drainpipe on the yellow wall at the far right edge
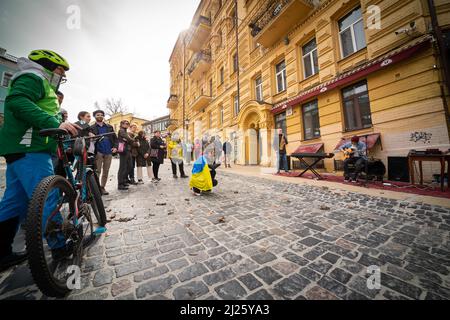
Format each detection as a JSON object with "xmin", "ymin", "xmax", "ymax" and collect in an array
[{"xmin": 428, "ymin": 0, "xmax": 450, "ymax": 136}]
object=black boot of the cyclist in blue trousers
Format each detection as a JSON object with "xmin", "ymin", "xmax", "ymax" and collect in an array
[{"xmin": 0, "ymin": 217, "xmax": 27, "ymax": 272}]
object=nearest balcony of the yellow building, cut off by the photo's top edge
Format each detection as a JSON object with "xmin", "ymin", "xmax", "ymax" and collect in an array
[{"xmin": 249, "ymin": 0, "xmax": 314, "ymax": 48}]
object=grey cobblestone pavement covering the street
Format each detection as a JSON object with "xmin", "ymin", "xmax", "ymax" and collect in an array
[{"xmin": 0, "ymin": 162, "xmax": 450, "ymax": 300}]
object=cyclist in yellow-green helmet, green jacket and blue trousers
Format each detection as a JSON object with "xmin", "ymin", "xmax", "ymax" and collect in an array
[{"xmin": 0, "ymin": 50, "xmax": 80, "ymax": 271}]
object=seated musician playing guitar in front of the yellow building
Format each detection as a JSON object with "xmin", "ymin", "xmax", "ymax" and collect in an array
[{"xmin": 339, "ymin": 136, "xmax": 367, "ymax": 182}]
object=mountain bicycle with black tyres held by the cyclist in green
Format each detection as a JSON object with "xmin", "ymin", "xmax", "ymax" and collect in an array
[{"xmin": 25, "ymin": 129, "xmax": 113, "ymax": 298}]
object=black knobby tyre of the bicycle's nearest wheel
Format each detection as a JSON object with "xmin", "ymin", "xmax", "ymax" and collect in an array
[{"xmin": 25, "ymin": 176, "xmax": 76, "ymax": 298}]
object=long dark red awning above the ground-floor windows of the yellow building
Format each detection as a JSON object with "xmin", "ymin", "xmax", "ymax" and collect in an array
[{"xmin": 272, "ymin": 35, "xmax": 432, "ymax": 114}]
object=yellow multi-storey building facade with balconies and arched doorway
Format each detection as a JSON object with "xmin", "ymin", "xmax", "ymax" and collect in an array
[{"xmin": 167, "ymin": 0, "xmax": 450, "ymax": 180}]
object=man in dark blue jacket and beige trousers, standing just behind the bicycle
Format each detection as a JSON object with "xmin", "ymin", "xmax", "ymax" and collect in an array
[{"xmin": 91, "ymin": 110, "xmax": 118, "ymax": 195}]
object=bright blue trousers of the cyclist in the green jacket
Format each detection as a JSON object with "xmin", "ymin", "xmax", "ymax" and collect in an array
[{"xmin": 0, "ymin": 153, "xmax": 65, "ymax": 249}]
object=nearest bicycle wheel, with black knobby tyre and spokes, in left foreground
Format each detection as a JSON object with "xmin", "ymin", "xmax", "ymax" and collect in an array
[{"xmin": 25, "ymin": 176, "xmax": 77, "ymax": 298}]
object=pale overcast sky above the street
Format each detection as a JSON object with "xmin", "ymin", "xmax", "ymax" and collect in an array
[{"xmin": 0, "ymin": 0, "xmax": 200, "ymax": 120}]
